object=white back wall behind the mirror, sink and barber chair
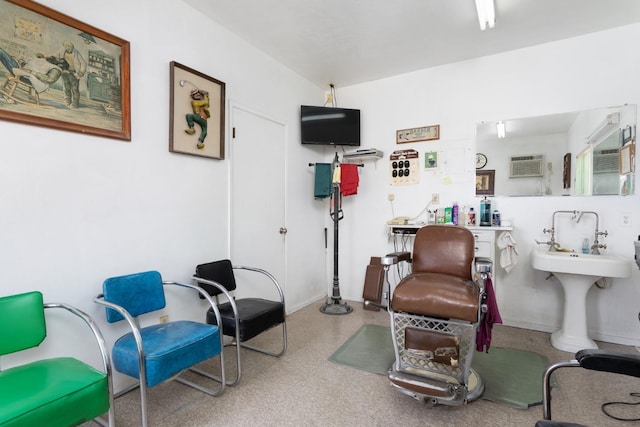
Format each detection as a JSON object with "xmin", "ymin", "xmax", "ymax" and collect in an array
[{"xmin": 338, "ymin": 25, "xmax": 640, "ymax": 345}]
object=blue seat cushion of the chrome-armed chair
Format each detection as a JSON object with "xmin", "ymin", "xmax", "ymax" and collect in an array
[{"xmin": 113, "ymin": 320, "xmax": 221, "ymax": 387}]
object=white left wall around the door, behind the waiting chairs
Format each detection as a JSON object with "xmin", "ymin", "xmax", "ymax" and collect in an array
[{"xmin": 0, "ymin": 0, "xmax": 325, "ymax": 388}]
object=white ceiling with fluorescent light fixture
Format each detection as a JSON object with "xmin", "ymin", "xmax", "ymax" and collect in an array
[{"xmin": 183, "ymin": 0, "xmax": 640, "ymax": 88}]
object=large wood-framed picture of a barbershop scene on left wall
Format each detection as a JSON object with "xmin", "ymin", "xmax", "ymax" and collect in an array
[{"xmin": 0, "ymin": 0, "xmax": 131, "ymax": 141}]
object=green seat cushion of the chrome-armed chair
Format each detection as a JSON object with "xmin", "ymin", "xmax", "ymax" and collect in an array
[{"xmin": 0, "ymin": 357, "xmax": 109, "ymax": 427}]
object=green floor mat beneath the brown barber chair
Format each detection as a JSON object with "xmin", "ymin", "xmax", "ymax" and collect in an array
[{"xmin": 329, "ymin": 325, "xmax": 555, "ymax": 409}]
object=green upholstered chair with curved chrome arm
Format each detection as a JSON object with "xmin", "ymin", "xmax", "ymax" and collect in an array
[{"xmin": 0, "ymin": 291, "xmax": 115, "ymax": 427}]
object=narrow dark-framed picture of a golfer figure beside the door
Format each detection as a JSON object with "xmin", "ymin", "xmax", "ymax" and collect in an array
[{"xmin": 169, "ymin": 61, "xmax": 225, "ymax": 159}]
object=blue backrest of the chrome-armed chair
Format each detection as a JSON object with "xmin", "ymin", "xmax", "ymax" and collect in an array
[{"xmin": 102, "ymin": 271, "xmax": 166, "ymax": 323}]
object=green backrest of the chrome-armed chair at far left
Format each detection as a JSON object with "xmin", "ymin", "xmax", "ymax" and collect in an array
[{"xmin": 0, "ymin": 291, "xmax": 47, "ymax": 355}]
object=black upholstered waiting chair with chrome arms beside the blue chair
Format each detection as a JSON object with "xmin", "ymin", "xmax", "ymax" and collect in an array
[{"xmin": 194, "ymin": 259, "xmax": 287, "ymax": 385}]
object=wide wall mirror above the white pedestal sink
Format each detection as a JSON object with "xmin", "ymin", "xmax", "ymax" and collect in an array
[{"xmin": 476, "ymin": 105, "xmax": 636, "ymax": 196}]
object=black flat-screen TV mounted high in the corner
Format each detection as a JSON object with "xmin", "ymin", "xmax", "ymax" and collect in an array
[{"xmin": 300, "ymin": 105, "xmax": 360, "ymax": 146}]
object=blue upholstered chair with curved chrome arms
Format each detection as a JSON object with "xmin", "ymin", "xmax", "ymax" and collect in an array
[{"xmin": 95, "ymin": 271, "xmax": 225, "ymax": 426}]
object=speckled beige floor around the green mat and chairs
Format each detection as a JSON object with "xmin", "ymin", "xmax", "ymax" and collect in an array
[{"xmin": 95, "ymin": 301, "xmax": 640, "ymax": 427}]
